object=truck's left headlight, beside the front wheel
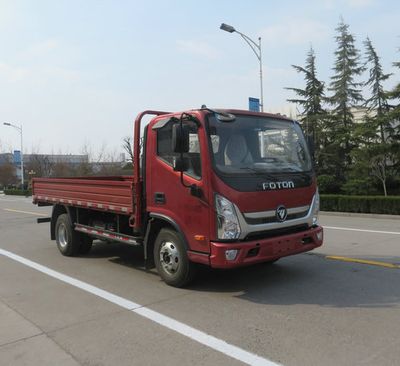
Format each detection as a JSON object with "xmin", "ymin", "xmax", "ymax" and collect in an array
[{"xmin": 215, "ymin": 194, "xmax": 240, "ymax": 239}]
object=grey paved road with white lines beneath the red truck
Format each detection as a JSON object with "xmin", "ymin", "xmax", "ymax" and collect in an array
[{"xmin": 0, "ymin": 196, "xmax": 400, "ymax": 366}]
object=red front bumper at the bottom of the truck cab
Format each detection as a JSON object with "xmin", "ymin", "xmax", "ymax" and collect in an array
[{"xmin": 209, "ymin": 226, "xmax": 323, "ymax": 268}]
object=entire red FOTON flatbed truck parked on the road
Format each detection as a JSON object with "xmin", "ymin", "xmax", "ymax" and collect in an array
[{"xmin": 32, "ymin": 107, "xmax": 323, "ymax": 287}]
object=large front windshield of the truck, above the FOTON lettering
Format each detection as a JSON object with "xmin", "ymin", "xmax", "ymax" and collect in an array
[{"xmin": 209, "ymin": 115, "xmax": 312, "ymax": 175}]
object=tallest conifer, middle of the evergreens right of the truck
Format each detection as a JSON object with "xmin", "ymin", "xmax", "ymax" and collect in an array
[{"xmin": 327, "ymin": 19, "xmax": 364, "ymax": 175}]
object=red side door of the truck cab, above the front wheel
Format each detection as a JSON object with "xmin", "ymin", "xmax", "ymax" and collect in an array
[{"xmin": 146, "ymin": 117, "xmax": 210, "ymax": 254}]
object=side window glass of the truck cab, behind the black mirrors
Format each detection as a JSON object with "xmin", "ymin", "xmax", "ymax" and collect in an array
[{"xmin": 157, "ymin": 121, "xmax": 201, "ymax": 179}]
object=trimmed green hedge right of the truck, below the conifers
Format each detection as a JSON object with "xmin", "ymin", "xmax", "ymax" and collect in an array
[{"xmin": 321, "ymin": 194, "xmax": 400, "ymax": 215}]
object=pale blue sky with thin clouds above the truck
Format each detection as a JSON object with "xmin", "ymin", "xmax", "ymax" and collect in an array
[{"xmin": 0, "ymin": 0, "xmax": 400, "ymax": 158}]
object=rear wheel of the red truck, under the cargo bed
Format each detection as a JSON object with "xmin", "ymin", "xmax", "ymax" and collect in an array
[{"xmin": 55, "ymin": 213, "xmax": 81, "ymax": 257}]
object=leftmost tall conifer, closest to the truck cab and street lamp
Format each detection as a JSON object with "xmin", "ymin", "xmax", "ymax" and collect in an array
[{"xmin": 286, "ymin": 47, "xmax": 326, "ymax": 167}]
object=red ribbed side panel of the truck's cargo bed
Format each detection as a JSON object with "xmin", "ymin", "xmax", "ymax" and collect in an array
[{"xmin": 32, "ymin": 176, "xmax": 134, "ymax": 215}]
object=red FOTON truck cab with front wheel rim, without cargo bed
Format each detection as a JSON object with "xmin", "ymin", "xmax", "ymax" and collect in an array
[{"xmin": 142, "ymin": 109, "xmax": 323, "ymax": 286}]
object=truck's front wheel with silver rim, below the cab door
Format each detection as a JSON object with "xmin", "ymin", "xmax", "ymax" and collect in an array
[{"xmin": 154, "ymin": 228, "xmax": 196, "ymax": 287}]
